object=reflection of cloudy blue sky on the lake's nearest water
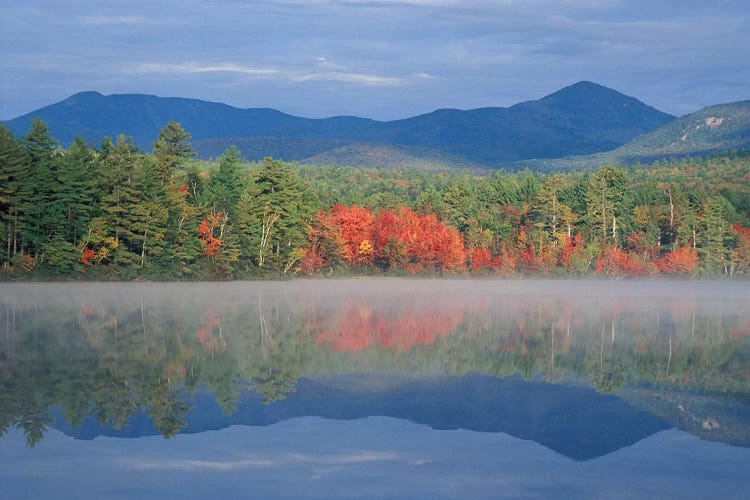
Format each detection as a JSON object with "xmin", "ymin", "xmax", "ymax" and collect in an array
[{"xmin": 0, "ymin": 417, "xmax": 750, "ymax": 499}]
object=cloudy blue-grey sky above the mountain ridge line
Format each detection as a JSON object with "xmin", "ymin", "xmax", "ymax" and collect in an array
[{"xmin": 0, "ymin": 0, "xmax": 750, "ymax": 120}]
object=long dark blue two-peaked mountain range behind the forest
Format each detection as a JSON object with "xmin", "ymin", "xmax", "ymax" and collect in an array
[{"xmin": 5, "ymin": 82, "xmax": 674, "ymax": 168}]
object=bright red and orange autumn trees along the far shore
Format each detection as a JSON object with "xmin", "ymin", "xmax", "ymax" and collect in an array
[{"xmin": 298, "ymin": 205, "xmax": 728, "ymax": 277}]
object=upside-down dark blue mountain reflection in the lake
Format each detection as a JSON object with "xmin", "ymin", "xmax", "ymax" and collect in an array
[{"xmin": 54, "ymin": 374, "xmax": 669, "ymax": 460}]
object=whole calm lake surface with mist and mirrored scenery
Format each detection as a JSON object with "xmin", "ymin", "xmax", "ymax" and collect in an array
[{"xmin": 0, "ymin": 279, "xmax": 750, "ymax": 498}]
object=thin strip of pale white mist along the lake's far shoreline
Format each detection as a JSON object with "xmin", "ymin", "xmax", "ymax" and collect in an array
[{"xmin": 0, "ymin": 278, "xmax": 750, "ymax": 307}]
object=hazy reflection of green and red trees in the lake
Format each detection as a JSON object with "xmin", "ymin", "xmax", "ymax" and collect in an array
[{"xmin": 0, "ymin": 285, "xmax": 750, "ymax": 446}]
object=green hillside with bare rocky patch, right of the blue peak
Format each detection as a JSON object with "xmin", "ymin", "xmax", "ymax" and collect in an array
[{"xmin": 517, "ymin": 101, "xmax": 750, "ymax": 169}]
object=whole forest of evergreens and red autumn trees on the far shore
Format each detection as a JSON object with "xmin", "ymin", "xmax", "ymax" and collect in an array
[{"xmin": 0, "ymin": 119, "xmax": 750, "ymax": 280}]
